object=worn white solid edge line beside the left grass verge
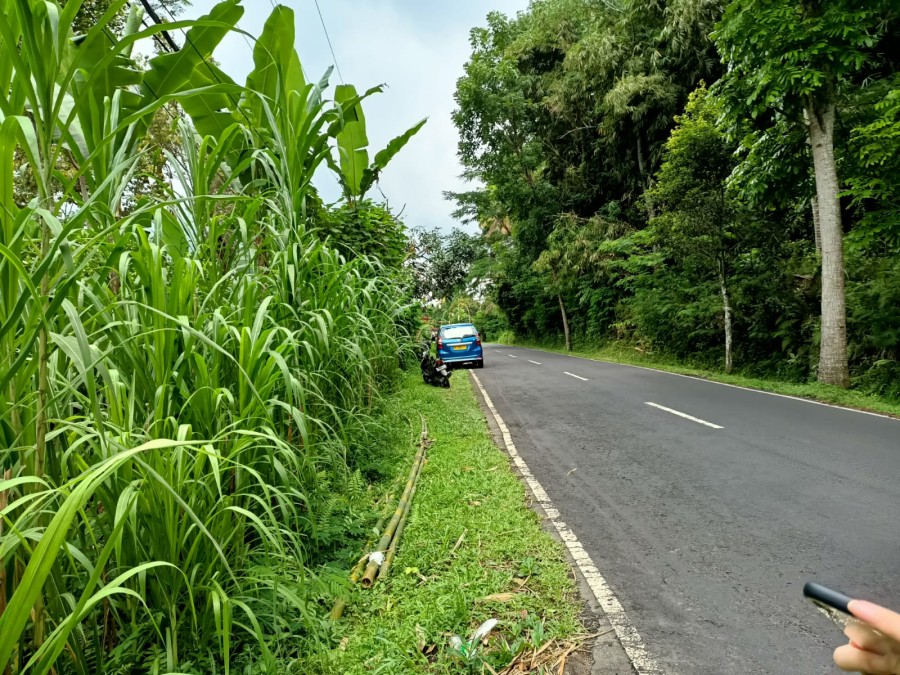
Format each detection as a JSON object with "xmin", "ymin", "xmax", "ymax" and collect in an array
[{"xmin": 470, "ymin": 373, "xmax": 662, "ymax": 675}]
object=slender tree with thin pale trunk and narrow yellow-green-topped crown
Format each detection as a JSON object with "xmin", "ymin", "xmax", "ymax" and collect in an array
[{"xmin": 648, "ymin": 87, "xmax": 738, "ymax": 372}]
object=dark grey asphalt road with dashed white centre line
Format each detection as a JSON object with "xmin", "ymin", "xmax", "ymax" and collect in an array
[{"xmin": 476, "ymin": 345, "xmax": 900, "ymax": 675}]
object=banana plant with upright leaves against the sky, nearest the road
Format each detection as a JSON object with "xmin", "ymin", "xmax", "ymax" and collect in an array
[{"xmin": 330, "ymin": 84, "xmax": 428, "ymax": 202}]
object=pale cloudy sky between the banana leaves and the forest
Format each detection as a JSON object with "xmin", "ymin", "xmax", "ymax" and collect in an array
[{"xmin": 175, "ymin": 0, "xmax": 528, "ymax": 229}]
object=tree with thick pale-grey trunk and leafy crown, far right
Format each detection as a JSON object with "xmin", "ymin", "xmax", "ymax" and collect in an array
[{"xmin": 714, "ymin": 0, "xmax": 889, "ymax": 387}]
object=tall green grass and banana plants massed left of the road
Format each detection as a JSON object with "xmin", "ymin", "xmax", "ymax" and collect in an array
[{"xmin": 0, "ymin": 0, "xmax": 418, "ymax": 674}]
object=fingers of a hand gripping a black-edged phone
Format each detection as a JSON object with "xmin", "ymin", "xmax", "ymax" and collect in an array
[{"xmin": 834, "ymin": 600, "xmax": 900, "ymax": 675}]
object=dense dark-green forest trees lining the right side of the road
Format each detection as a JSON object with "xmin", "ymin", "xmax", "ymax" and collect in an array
[{"xmin": 453, "ymin": 0, "xmax": 900, "ymax": 397}]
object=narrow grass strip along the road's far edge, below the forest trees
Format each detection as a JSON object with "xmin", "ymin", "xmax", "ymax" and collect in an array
[{"xmin": 503, "ymin": 340, "xmax": 900, "ymax": 417}]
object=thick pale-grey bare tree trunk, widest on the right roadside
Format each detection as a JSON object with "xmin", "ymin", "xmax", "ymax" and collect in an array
[{"xmin": 806, "ymin": 97, "xmax": 850, "ymax": 387}]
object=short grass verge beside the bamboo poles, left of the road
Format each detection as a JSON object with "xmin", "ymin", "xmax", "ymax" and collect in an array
[{"xmin": 293, "ymin": 372, "xmax": 582, "ymax": 674}]
